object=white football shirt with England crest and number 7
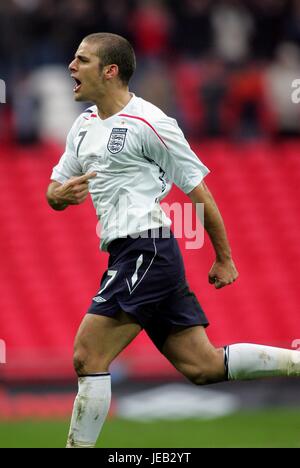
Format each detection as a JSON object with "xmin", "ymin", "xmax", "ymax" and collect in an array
[{"xmin": 51, "ymin": 94, "xmax": 209, "ymax": 250}]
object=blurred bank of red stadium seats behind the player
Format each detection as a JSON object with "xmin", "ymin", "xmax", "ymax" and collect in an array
[{"xmin": 0, "ymin": 142, "xmax": 300, "ymax": 379}]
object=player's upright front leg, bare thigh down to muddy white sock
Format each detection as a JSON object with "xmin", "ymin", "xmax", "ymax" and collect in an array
[{"xmin": 67, "ymin": 312, "xmax": 141, "ymax": 448}]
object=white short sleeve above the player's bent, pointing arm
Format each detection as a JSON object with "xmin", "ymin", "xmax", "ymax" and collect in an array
[{"xmin": 51, "ymin": 126, "xmax": 82, "ymax": 184}]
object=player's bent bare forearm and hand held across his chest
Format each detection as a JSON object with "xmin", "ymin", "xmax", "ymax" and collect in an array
[{"xmin": 47, "ymin": 172, "xmax": 97, "ymax": 211}]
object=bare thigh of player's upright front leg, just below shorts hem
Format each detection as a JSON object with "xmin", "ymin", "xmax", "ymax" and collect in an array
[{"xmin": 74, "ymin": 311, "xmax": 142, "ymax": 362}]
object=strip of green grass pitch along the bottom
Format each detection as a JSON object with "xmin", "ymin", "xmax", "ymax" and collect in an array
[{"xmin": 0, "ymin": 409, "xmax": 300, "ymax": 448}]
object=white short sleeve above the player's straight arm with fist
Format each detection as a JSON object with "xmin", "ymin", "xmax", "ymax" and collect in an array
[{"xmin": 143, "ymin": 117, "xmax": 210, "ymax": 193}]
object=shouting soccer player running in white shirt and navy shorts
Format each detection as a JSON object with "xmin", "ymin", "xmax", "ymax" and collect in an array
[{"xmin": 47, "ymin": 33, "xmax": 300, "ymax": 447}]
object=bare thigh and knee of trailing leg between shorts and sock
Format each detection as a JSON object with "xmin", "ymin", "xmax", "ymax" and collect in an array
[{"xmin": 162, "ymin": 326, "xmax": 224, "ymax": 380}]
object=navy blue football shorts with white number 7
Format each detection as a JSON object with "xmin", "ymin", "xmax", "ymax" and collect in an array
[{"xmin": 87, "ymin": 228, "xmax": 209, "ymax": 350}]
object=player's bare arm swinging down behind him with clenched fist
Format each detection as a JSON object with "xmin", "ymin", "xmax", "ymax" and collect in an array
[{"xmin": 188, "ymin": 182, "xmax": 238, "ymax": 289}]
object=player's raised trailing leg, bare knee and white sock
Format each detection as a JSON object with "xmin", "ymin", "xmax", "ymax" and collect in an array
[{"xmin": 162, "ymin": 326, "xmax": 300, "ymax": 385}]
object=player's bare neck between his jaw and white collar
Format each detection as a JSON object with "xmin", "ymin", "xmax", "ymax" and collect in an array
[{"xmin": 95, "ymin": 88, "xmax": 132, "ymax": 120}]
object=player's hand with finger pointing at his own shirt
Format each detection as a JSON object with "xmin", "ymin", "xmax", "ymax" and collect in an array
[{"xmin": 55, "ymin": 172, "xmax": 97, "ymax": 205}]
